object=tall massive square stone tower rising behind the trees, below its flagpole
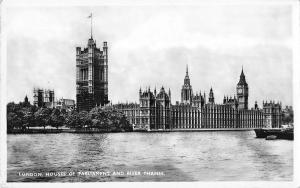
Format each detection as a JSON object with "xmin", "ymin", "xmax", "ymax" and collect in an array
[{"xmin": 76, "ymin": 36, "xmax": 109, "ymax": 111}]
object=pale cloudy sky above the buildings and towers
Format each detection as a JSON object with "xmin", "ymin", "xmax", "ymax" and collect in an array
[{"xmin": 5, "ymin": 4, "xmax": 293, "ymax": 107}]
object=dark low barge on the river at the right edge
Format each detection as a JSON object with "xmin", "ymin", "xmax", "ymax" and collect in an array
[{"xmin": 254, "ymin": 127, "xmax": 294, "ymax": 140}]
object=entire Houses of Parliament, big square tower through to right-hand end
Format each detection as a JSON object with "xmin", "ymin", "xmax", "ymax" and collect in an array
[{"xmin": 76, "ymin": 34, "xmax": 282, "ymax": 130}]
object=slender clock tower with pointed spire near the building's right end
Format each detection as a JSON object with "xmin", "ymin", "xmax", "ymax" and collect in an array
[{"xmin": 236, "ymin": 69, "xmax": 249, "ymax": 110}]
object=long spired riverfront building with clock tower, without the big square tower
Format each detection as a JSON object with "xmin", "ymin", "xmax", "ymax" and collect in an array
[{"xmin": 114, "ymin": 67, "xmax": 282, "ymax": 130}]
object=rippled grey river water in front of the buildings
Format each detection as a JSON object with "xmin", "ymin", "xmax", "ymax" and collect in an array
[{"xmin": 7, "ymin": 131, "xmax": 293, "ymax": 182}]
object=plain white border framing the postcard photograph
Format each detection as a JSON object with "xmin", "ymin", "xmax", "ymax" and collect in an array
[{"xmin": 0, "ymin": 0, "xmax": 300, "ymax": 188}]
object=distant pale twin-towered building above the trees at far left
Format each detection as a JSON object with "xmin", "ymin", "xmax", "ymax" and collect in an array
[{"xmin": 33, "ymin": 88, "xmax": 55, "ymax": 108}]
